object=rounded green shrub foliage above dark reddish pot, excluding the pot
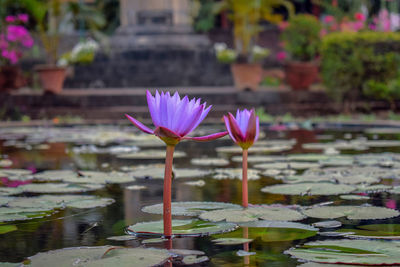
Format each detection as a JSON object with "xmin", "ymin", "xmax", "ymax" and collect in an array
[{"xmin": 282, "ymin": 15, "xmax": 321, "ymax": 61}]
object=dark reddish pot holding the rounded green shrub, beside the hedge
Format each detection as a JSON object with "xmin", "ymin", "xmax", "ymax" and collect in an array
[{"xmin": 285, "ymin": 61, "xmax": 318, "ymax": 90}]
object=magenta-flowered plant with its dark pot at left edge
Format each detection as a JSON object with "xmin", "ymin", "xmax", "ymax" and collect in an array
[{"xmin": 0, "ymin": 14, "xmax": 33, "ymax": 91}]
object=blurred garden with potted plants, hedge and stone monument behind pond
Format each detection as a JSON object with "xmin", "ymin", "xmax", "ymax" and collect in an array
[{"xmin": 0, "ymin": 0, "xmax": 400, "ymax": 124}]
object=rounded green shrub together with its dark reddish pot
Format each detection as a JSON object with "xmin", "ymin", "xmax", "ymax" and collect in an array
[{"xmin": 282, "ymin": 15, "xmax": 321, "ymax": 90}]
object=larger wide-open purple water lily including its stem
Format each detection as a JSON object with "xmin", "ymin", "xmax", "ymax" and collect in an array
[{"xmin": 125, "ymin": 91, "xmax": 228, "ymax": 238}]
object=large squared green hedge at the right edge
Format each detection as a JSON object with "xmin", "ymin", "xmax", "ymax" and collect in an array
[{"xmin": 321, "ymin": 32, "xmax": 400, "ymax": 102}]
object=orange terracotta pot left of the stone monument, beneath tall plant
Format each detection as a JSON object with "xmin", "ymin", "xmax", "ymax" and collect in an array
[{"xmin": 35, "ymin": 65, "xmax": 66, "ymax": 94}]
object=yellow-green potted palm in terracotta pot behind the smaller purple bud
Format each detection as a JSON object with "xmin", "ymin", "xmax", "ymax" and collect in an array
[{"xmin": 212, "ymin": 0, "xmax": 294, "ymax": 90}]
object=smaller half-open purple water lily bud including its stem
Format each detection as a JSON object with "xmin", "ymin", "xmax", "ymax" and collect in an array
[{"xmin": 224, "ymin": 109, "xmax": 260, "ymax": 208}]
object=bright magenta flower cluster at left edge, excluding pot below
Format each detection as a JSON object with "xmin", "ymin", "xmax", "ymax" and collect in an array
[{"xmin": 0, "ymin": 14, "xmax": 34, "ymax": 65}]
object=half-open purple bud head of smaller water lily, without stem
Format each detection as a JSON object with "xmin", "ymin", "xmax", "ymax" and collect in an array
[{"xmin": 224, "ymin": 109, "xmax": 260, "ymax": 149}]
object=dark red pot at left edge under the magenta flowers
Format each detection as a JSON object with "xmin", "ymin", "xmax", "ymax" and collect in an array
[{"xmin": 0, "ymin": 66, "xmax": 26, "ymax": 91}]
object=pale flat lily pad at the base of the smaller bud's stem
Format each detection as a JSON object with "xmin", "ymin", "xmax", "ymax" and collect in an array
[{"xmin": 199, "ymin": 206, "xmax": 305, "ymax": 223}]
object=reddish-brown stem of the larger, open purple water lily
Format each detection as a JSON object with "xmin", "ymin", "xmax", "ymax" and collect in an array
[{"xmin": 163, "ymin": 146, "xmax": 175, "ymax": 238}]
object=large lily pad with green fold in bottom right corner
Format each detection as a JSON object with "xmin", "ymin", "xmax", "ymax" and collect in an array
[{"xmin": 285, "ymin": 239, "xmax": 400, "ymax": 265}]
